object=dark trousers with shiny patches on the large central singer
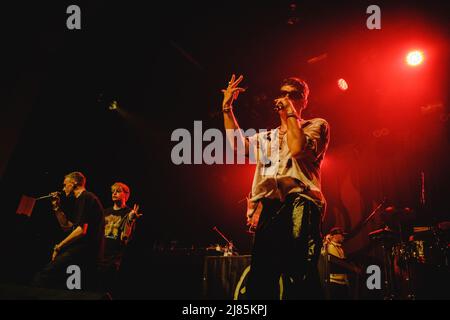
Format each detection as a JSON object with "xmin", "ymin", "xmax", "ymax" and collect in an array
[{"xmin": 247, "ymin": 194, "xmax": 323, "ymax": 299}]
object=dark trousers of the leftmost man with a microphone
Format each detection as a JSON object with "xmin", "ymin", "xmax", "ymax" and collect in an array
[{"xmin": 31, "ymin": 246, "xmax": 96, "ymax": 289}]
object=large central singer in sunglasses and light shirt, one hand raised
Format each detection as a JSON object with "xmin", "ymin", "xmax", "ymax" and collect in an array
[{"xmin": 222, "ymin": 75, "xmax": 330, "ymax": 299}]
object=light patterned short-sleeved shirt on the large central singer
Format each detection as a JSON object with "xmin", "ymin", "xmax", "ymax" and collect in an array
[{"xmin": 249, "ymin": 118, "xmax": 330, "ymax": 208}]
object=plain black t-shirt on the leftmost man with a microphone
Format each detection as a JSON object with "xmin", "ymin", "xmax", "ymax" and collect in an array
[{"xmin": 67, "ymin": 191, "xmax": 105, "ymax": 256}]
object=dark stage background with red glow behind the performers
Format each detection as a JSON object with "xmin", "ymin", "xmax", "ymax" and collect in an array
[{"xmin": 0, "ymin": 1, "xmax": 450, "ymax": 298}]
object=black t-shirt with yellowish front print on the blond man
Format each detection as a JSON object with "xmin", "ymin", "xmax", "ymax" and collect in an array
[{"xmin": 105, "ymin": 206, "xmax": 131, "ymax": 258}]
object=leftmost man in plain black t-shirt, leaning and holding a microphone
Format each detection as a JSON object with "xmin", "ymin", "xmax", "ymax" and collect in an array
[{"xmin": 32, "ymin": 172, "xmax": 105, "ymax": 289}]
